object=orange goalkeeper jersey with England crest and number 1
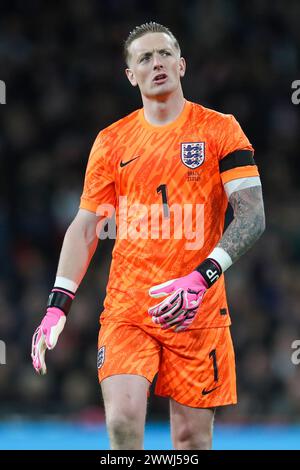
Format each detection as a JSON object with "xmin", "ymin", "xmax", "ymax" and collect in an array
[{"xmin": 80, "ymin": 101, "xmax": 258, "ymax": 329}]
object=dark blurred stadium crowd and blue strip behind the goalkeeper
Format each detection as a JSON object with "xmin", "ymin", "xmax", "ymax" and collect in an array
[{"xmin": 0, "ymin": 0, "xmax": 300, "ymax": 449}]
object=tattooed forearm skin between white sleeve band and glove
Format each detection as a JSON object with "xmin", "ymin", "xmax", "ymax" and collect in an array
[{"xmin": 217, "ymin": 186, "xmax": 265, "ymax": 262}]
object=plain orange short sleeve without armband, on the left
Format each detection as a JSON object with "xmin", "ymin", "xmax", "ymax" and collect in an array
[{"xmin": 79, "ymin": 132, "xmax": 116, "ymax": 212}]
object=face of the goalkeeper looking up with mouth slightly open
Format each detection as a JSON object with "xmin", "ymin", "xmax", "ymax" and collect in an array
[{"xmin": 126, "ymin": 33, "xmax": 185, "ymax": 98}]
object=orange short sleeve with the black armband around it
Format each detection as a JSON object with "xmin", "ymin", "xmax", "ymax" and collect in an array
[{"xmin": 218, "ymin": 114, "xmax": 259, "ymax": 184}]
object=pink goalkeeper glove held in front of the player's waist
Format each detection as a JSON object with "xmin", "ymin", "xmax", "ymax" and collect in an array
[{"xmin": 148, "ymin": 258, "xmax": 222, "ymax": 332}]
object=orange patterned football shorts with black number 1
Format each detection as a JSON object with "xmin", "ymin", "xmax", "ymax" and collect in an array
[{"xmin": 98, "ymin": 319, "xmax": 237, "ymax": 408}]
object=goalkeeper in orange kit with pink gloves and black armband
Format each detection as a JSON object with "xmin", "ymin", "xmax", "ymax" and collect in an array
[{"xmin": 32, "ymin": 22, "xmax": 265, "ymax": 450}]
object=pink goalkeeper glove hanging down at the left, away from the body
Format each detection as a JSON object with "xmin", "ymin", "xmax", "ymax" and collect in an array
[{"xmin": 31, "ymin": 288, "xmax": 74, "ymax": 375}]
